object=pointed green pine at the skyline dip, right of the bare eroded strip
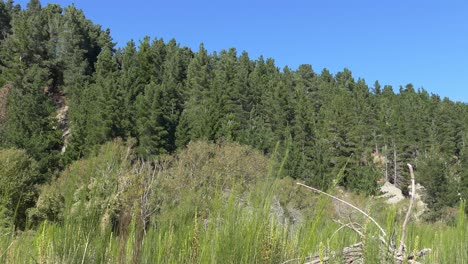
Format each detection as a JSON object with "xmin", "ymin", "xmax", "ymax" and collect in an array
[{"xmin": 67, "ymin": 46, "xmax": 120, "ymax": 160}]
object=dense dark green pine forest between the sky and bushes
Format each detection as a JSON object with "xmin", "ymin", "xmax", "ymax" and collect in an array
[{"xmin": 0, "ymin": 0, "xmax": 468, "ymax": 231}]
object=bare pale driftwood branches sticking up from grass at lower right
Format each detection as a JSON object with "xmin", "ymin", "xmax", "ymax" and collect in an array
[{"xmin": 283, "ymin": 164, "xmax": 431, "ymax": 264}]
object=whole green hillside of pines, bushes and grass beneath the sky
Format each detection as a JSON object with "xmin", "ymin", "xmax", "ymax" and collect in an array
[{"xmin": 0, "ymin": 0, "xmax": 468, "ymax": 263}]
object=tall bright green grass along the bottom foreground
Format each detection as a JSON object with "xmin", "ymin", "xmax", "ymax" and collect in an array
[{"xmin": 0, "ymin": 187, "xmax": 468, "ymax": 263}]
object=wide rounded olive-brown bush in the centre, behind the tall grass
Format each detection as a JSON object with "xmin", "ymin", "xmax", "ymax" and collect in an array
[{"xmin": 152, "ymin": 142, "xmax": 268, "ymax": 227}]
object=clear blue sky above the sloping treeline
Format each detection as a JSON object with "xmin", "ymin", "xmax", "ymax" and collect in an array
[{"xmin": 16, "ymin": 0, "xmax": 468, "ymax": 102}]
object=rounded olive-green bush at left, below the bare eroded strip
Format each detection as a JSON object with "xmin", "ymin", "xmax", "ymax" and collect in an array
[{"xmin": 30, "ymin": 140, "xmax": 132, "ymax": 226}]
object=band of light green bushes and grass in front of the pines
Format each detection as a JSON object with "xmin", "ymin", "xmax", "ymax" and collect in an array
[{"xmin": 0, "ymin": 141, "xmax": 468, "ymax": 264}]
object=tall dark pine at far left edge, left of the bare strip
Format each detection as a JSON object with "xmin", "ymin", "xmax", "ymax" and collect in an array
[{"xmin": 1, "ymin": 1, "xmax": 61, "ymax": 174}]
